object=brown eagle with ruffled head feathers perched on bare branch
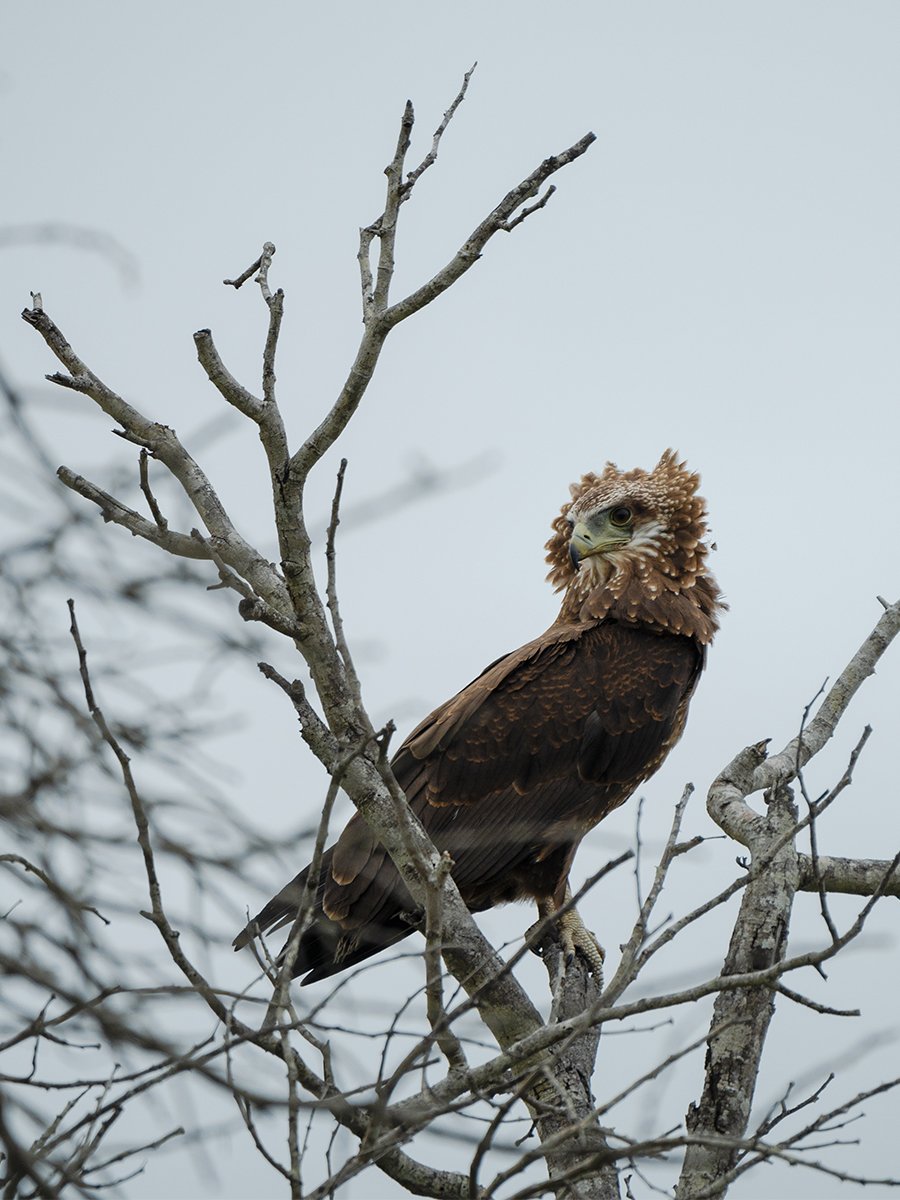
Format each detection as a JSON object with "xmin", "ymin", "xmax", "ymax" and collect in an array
[{"xmin": 234, "ymin": 450, "xmax": 725, "ymax": 984}]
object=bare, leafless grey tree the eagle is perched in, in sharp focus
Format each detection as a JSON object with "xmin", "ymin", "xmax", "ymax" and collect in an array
[{"xmin": 7, "ymin": 72, "xmax": 900, "ymax": 1200}]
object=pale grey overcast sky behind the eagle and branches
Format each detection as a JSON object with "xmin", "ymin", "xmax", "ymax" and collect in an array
[{"xmin": 0, "ymin": 0, "xmax": 900, "ymax": 1198}]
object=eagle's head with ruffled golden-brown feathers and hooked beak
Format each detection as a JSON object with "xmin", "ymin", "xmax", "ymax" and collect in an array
[{"xmin": 547, "ymin": 450, "xmax": 707, "ymax": 589}]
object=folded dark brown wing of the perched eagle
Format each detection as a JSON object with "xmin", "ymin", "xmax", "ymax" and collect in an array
[{"xmin": 324, "ymin": 620, "xmax": 702, "ymax": 926}]
